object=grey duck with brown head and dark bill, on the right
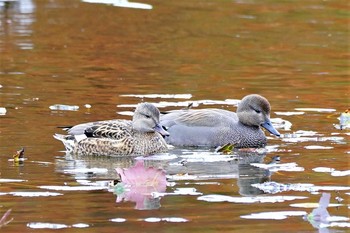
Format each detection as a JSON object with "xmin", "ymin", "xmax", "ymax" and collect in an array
[{"xmin": 160, "ymin": 94, "xmax": 280, "ymax": 148}]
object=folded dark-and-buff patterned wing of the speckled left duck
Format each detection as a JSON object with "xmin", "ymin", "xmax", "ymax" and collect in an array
[{"xmin": 68, "ymin": 120, "xmax": 132, "ymax": 139}]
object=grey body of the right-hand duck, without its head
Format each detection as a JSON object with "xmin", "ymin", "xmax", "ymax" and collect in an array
[{"xmin": 161, "ymin": 109, "xmax": 266, "ymax": 148}]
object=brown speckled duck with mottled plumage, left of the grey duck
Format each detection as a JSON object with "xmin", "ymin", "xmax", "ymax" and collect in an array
[{"xmin": 54, "ymin": 103, "xmax": 169, "ymax": 156}]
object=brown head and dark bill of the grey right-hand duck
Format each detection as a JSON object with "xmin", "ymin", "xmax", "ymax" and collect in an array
[{"xmin": 237, "ymin": 94, "xmax": 280, "ymax": 136}]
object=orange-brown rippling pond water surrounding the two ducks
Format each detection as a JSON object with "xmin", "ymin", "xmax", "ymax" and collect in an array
[{"xmin": 0, "ymin": 0, "xmax": 350, "ymax": 232}]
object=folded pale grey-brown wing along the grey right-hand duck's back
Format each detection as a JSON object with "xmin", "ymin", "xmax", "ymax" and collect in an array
[{"xmin": 160, "ymin": 109, "xmax": 238, "ymax": 128}]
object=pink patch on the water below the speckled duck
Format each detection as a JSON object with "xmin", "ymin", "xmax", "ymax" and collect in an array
[{"xmin": 114, "ymin": 160, "xmax": 166, "ymax": 210}]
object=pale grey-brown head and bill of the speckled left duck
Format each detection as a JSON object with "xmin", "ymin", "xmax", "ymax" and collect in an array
[{"xmin": 132, "ymin": 103, "xmax": 169, "ymax": 136}]
